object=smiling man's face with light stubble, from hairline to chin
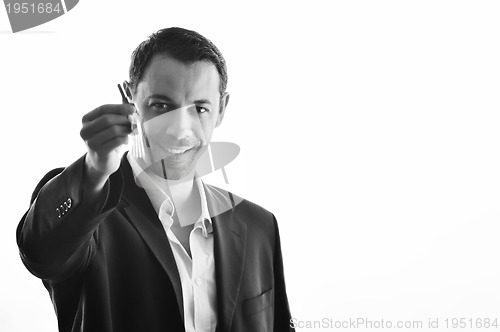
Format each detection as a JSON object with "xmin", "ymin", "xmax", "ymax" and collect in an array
[{"xmin": 133, "ymin": 55, "xmax": 228, "ymax": 180}]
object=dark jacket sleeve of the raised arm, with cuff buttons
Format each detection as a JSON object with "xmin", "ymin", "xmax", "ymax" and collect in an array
[{"xmin": 16, "ymin": 156, "xmax": 123, "ymax": 282}]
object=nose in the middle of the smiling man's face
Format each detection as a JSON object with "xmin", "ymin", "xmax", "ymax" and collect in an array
[{"xmin": 167, "ymin": 106, "xmax": 200, "ymax": 139}]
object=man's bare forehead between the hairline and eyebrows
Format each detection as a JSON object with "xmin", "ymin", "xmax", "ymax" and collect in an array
[{"xmin": 138, "ymin": 55, "xmax": 220, "ymax": 99}]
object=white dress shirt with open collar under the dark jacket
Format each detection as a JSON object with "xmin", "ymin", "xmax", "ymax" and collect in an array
[{"xmin": 127, "ymin": 153, "xmax": 217, "ymax": 332}]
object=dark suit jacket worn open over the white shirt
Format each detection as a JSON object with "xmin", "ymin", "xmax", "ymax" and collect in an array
[{"xmin": 17, "ymin": 157, "xmax": 293, "ymax": 332}]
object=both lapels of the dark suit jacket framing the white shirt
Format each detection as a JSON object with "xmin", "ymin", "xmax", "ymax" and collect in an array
[{"xmin": 121, "ymin": 156, "xmax": 247, "ymax": 331}]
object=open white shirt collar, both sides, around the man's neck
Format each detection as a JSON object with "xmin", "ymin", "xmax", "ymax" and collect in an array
[{"xmin": 127, "ymin": 153, "xmax": 213, "ymax": 237}]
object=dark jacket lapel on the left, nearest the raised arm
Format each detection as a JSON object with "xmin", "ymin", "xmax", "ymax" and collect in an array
[{"xmin": 121, "ymin": 157, "xmax": 184, "ymax": 321}]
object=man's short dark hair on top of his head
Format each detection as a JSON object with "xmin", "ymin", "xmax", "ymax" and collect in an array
[{"xmin": 129, "ymin": 27, "xmax": 227, "ymax": 97}]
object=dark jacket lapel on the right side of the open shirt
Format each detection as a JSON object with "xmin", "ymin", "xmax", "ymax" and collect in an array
[{"xmin": 205, "ymin": 185, "xmax": 247, "ymax": 331}]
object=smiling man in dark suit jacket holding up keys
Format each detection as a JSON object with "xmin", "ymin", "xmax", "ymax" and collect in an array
[{"xmin": 17, "ymin": 28, "xmax": 292, "ymax": 332}]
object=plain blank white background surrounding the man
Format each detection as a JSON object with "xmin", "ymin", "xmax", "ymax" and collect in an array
[{"xmin": 0, "ymin": 0, "xmax": 500, "ymax": 332}]
